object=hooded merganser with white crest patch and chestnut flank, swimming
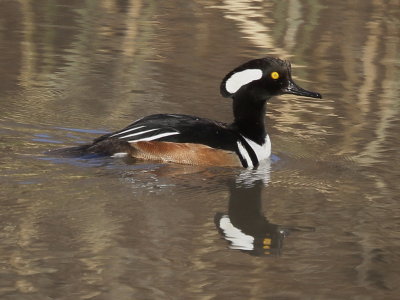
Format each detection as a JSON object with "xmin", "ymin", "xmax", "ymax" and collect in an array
[{"xmin": 59, "ymin": 57, "xmax": 322, "ymax": 168}]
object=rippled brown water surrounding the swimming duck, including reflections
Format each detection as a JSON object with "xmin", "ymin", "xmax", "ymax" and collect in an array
[{"xmin": 0, "ymin": 0, "xmax": 400, "ymax": 299}]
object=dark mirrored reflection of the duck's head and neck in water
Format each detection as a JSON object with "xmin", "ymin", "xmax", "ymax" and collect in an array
[{"xmin": 214, "ymin": 163, "xmax": 315, "ymax": 256}]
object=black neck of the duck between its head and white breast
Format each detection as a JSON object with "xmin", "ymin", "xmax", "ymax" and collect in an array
[{"xmin": 231, "ymin": 95, "xmax": 267, "ymax": 145}]
